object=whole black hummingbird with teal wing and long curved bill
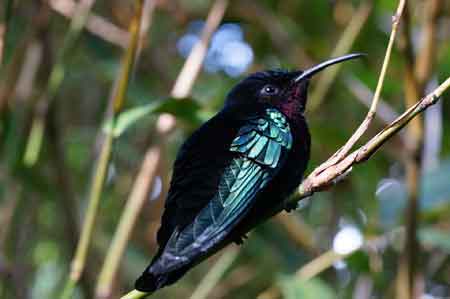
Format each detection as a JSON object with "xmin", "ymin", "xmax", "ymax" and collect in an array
[{"xmin": 135, "ymin": 53, "xmax": 363, "ymax": 293}]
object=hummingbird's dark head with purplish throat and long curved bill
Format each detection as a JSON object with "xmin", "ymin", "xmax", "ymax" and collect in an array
[{"xmin": 225, "ymin": 54, "xmax": 363, "ymax": 118}]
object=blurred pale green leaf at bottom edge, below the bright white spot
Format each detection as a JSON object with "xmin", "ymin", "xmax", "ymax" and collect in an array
[{"xmin": 281, "ymin": 276, "xmax": 335, "ymax": 299}]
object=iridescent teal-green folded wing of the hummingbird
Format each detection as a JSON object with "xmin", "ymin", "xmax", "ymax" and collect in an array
[{"xmin": 156, "ymin": 109, "xmax": 292, "ymax": 271}]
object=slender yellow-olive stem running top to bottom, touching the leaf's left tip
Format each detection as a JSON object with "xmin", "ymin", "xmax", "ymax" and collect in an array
[{"xmin": 61, "ymin": 0, "xmax": 143, "ymax": 299}]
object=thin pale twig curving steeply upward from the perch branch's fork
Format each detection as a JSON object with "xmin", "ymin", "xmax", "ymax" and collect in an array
[{"xmin": 315, "ymin": 0, "xmax": 406, "ymax": 173}]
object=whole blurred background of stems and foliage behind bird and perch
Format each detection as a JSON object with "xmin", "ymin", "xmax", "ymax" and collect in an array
[{"xmin": 0, "ymin": 0, "xmax": 450, "ymax": 299}]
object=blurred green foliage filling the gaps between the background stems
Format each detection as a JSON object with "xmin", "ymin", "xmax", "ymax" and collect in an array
[{"xmin": 0, "ymin": 0, "xmax": 450, "ymax": 299}]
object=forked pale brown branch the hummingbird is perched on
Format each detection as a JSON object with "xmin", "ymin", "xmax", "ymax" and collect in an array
[{"xmin": 118, "ymin": 0, "xmax": 450, "ymax": 299}]
